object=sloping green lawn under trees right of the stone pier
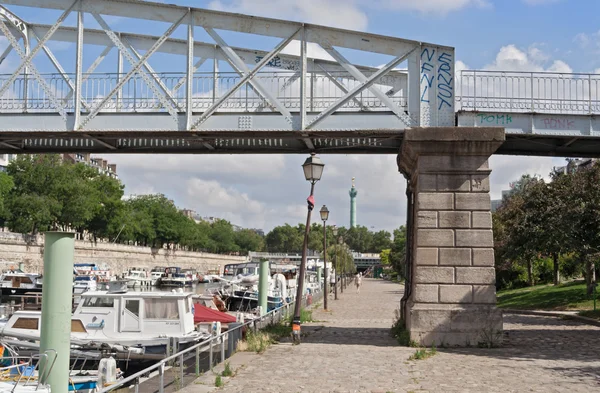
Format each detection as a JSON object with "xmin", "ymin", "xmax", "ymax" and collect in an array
[{"xmin": 498, "ymin": 281, "xmax": 594, "ymax": 311}]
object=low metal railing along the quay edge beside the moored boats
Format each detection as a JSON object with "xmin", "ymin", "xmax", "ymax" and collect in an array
[{"xmin": 99, "ymin": 291, "xmax": 323, "ymax": 393}]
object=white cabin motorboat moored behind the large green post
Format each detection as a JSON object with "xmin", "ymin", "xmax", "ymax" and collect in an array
[{"xmin": 0, "ymin": 291, "xmax": 210, "ymax": 354}]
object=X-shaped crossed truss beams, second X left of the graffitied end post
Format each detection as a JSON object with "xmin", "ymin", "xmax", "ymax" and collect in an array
[{"xmin": 191, "ymin": 29, "xmax": 300, "ymax": 130}]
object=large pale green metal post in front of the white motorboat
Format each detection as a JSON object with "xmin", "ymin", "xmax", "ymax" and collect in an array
[{"xmin": 40, "ymin": 232, "xmax": 75, "ymax": 393}]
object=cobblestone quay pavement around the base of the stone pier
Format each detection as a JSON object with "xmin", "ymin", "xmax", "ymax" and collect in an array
[{"xmin": 211, "ymin": 279, "xmax": 600, "ymax": 393}]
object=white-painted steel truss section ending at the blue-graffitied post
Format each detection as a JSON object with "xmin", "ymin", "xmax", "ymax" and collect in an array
[{"xmin": 0, "ymin": 0, "xmax": 454, "ymax": 142}]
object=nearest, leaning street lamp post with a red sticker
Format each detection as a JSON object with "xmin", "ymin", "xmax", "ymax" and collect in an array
[{"xmin": 292, "ymin": 153, "xmax": 325, "ymax": 344}]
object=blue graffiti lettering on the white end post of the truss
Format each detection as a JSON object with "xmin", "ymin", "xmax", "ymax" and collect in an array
[{"xmin": 421, "ymin": 48, "xmax": 454, "ymax": 110}]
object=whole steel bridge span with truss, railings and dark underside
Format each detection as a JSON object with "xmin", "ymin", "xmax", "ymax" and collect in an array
[{"xmin": 0, "ymin": 0, "xmax": 600, "ymax": 157}]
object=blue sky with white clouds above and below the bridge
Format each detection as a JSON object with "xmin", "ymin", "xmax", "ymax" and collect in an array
[{"xmin": 0, "ymin": 0, "xmax": 600, "ymax": 231}]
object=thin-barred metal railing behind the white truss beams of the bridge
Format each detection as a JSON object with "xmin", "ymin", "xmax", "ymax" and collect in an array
[{"xmin": 0, "ymin": 71, "xmax": 407, "ymax": 113}]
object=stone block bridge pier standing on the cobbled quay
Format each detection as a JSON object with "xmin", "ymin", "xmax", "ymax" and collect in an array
[{"xmin": 398, "ymin": 127, "xmax": 504, "ymax": 346}]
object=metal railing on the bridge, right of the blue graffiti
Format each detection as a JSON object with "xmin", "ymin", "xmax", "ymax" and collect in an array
[{"xmin": 456, "ymin": 70, "xmax": 600, "ymax": 114}]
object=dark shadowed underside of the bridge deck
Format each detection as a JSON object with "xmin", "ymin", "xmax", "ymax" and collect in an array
[{"xmin": 0, "ymin": 124, "xmax": 600, "ymax": 157}]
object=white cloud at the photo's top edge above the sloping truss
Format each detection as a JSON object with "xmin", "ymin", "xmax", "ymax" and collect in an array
[{"xmin": 208, "ymin": 0, "xmax": 368, "ymax": 30}]
